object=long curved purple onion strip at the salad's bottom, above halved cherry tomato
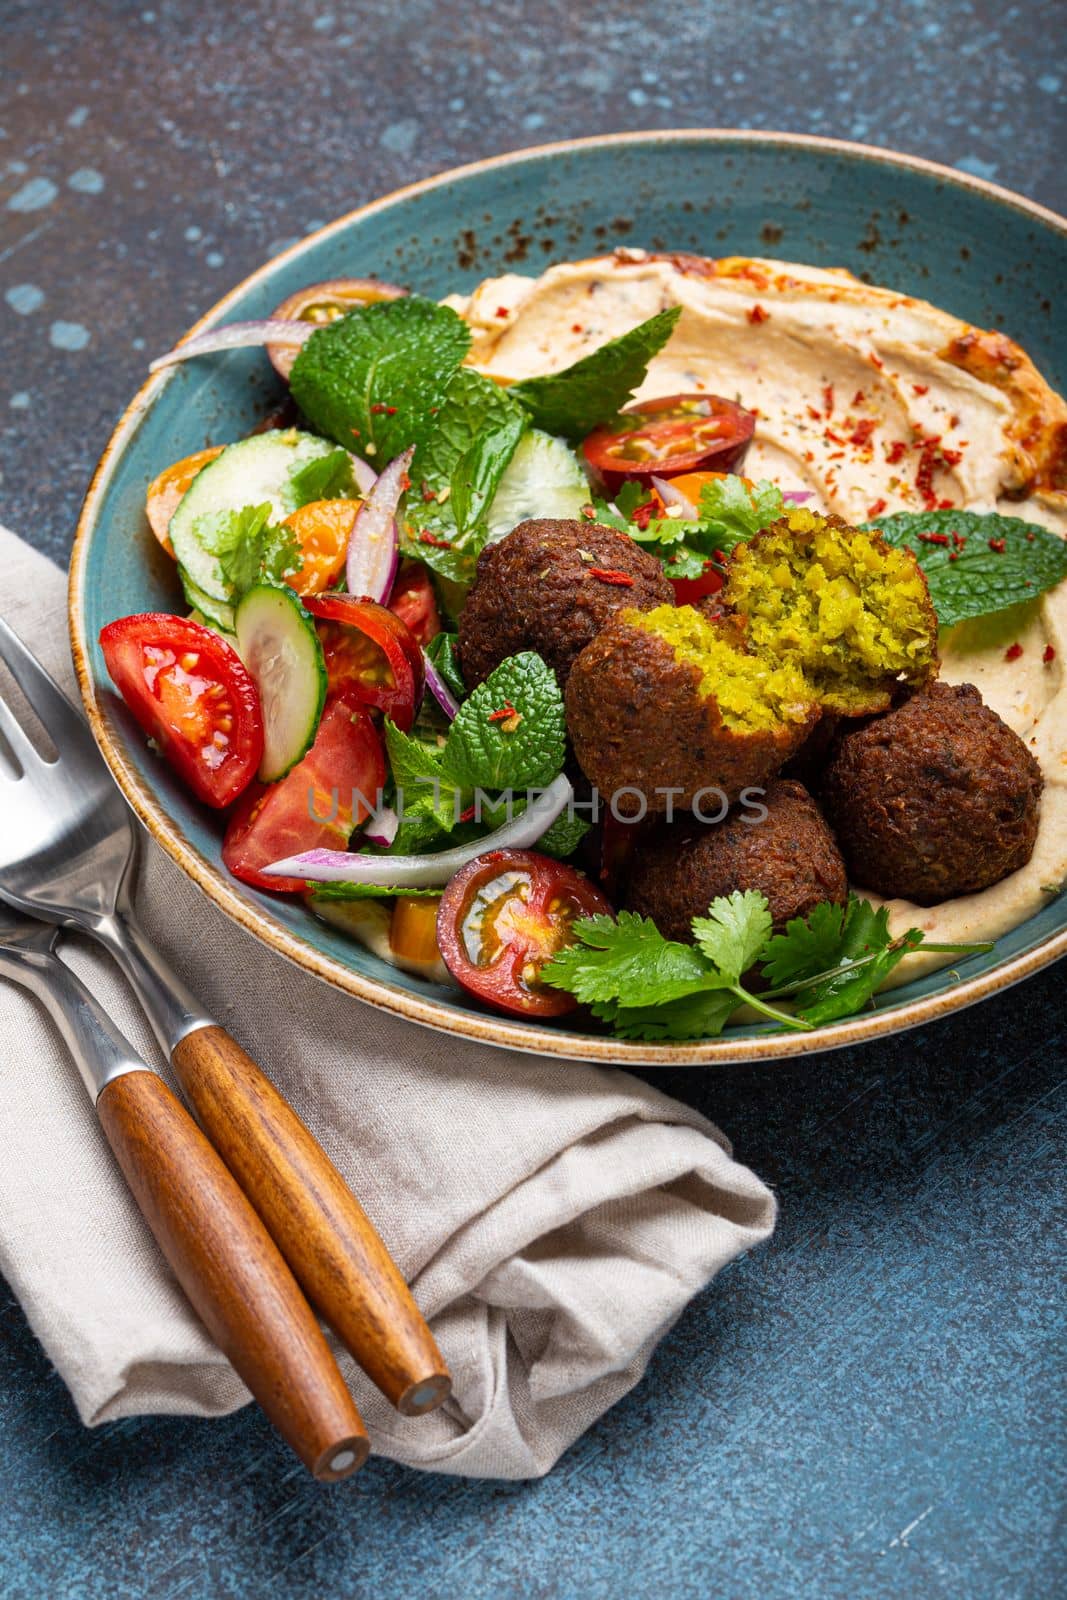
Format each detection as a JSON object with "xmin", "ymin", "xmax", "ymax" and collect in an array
[{"xmin": 262, "ymin": 773, "xmax": 574, "ymax": 890}]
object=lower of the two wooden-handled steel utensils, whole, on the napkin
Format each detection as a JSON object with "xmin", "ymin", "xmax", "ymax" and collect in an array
[{"xmin": 0, "ymin": 906, "xmax": 370, "ymax": 1480}]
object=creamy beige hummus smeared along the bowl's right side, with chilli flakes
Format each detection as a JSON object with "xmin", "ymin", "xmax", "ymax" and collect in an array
[{"xmin": 448, "ymin": 251, "xmax": 1067, "ymax": 982}]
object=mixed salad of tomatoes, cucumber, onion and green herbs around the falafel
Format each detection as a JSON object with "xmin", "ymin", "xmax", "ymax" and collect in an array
[{"xmin": 101, "ymin": 283, "xmax": 1067, "ymax": 1040}]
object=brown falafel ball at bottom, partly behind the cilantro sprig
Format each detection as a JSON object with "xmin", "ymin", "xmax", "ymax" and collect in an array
[{"xmin": 625, "ymin": 778, "xmax": 848, "ymax": 942}]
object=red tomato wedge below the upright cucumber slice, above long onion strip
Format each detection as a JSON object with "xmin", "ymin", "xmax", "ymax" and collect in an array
[{"xmin": 222, "ymin": 696, "xmax": 386, "ymax": 894}]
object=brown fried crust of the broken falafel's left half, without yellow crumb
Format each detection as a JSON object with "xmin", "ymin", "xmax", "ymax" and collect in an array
[{"xmin": 565, "ymin": 616, "xmax": 819, "ymax": 816}]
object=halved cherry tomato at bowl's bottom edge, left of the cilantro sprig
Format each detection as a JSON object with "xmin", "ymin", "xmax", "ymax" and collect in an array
[{"xmin": 437, "ymin": 850, "xmax": 611, "ymax": 1016}]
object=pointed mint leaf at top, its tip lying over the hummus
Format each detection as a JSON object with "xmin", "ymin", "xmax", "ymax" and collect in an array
[{"xmin": 507, "ymin": 306, "xmax": 681, "ymax": 442}]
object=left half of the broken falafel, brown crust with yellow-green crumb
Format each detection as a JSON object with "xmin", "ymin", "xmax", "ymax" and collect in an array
[{"xmin": 565, "ymin": 605, "xmax": 819, "ymax": 816}]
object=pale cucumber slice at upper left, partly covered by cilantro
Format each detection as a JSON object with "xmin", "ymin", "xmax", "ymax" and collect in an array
[{"xmin": 168, "ymin": 427, "xmax": 338, "ymax": 611}]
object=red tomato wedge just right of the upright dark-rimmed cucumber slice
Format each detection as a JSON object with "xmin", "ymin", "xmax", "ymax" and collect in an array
[{"xmin": 306, "ymin": 595, "xmax": 426, "ymax": 733}]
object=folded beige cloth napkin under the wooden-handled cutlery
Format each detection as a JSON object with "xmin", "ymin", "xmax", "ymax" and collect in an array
[{"xmin": 0, "ymin": 530, "xmax": 774, "ymax": 1478}]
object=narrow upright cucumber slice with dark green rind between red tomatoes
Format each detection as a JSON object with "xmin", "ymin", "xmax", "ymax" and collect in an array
[{"xmin": 234, "ymin": 584, "xmax": 326, "ymax": 784}]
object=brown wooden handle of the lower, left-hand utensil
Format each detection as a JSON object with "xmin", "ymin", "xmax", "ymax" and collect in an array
[{"xmin": 96, "ymin": 1069, "xmax": 370, "ymax": 1480}]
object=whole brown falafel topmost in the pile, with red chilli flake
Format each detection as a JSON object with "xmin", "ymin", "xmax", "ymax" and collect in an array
[{"xmin": 458, "ymin": 518, "xmax": 673, "ymax": 688}]
